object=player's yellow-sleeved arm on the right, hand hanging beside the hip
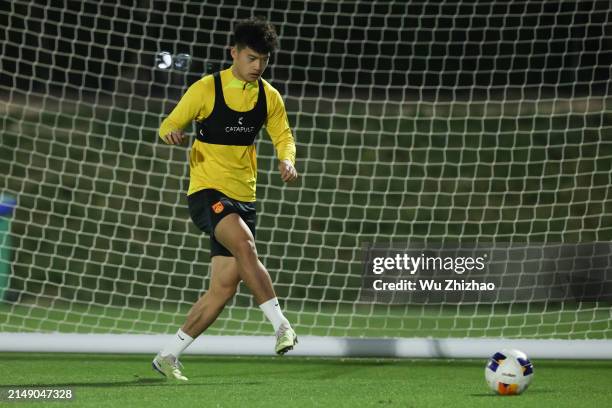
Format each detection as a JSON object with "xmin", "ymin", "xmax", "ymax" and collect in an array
[{"xmin": 266, "ymin": 89, "xmax": 298, "ymax": 183}]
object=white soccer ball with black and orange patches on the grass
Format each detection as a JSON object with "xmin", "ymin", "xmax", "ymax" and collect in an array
[{"xmin": 485, "ymin": 349, "xmax": 533, "ymax": 395}]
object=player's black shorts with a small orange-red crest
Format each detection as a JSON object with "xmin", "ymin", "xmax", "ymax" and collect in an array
[{"xmin": 187, "ymin": 189, "xmax": 257, "ymax": 258}]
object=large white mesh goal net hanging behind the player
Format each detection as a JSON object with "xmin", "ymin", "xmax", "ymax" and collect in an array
[{"xmin": 0, "ymin": 0, "xmax": 612, "ymax": 355}]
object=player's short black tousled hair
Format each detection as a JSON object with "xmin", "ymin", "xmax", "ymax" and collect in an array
[{"xmin": 234, "ymin": 17, "xmax": 278, "ymax": 54}]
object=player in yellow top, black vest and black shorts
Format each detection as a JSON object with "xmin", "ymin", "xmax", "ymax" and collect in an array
[{"xmin": 153, "ymin": 18, "xmax": 298, "ymax": 381}]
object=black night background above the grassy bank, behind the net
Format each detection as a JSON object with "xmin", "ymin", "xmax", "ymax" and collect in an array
[{"xmin": 0, "ymin": 0, "xmax": 612, "ymax": 98}]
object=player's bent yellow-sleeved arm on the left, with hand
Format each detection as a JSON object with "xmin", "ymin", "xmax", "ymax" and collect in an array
[{"xmin": 159, "ymin": 81, "xmax": 206, "ymax": 144}]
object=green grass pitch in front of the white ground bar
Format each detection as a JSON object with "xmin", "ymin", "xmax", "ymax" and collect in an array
[{"xmin": 0, "ymin": 353, "xmax": 612, "ymax": 408}]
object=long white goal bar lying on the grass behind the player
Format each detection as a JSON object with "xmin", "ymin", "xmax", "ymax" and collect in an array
[{"xmin": 0, "ymin": 333, "xmax": 612, "ymax": 360}]
